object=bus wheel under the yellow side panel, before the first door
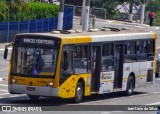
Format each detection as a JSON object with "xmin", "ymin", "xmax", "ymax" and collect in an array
[{"xmin": 74, "ymin": 82, "xmax": 84, "ymax": 103}]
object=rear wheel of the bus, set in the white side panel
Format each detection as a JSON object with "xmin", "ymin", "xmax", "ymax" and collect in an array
[{"xmin": 126, "ymin": 76, "xmax": 134, "ymax": 96}]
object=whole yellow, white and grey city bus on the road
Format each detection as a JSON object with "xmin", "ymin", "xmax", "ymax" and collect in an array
[{"xmin": 4, "ymin": 30, "xmax": 156, "ymax": 102}]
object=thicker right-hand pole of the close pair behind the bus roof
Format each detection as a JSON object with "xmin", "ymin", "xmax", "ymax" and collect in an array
[{"xmin": 82, "ymin": 0, "xmax": 90, "ymax": 31}]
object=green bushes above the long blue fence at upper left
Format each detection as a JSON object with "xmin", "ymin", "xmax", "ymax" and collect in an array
[{"xmin": 0, "ymin": 2, "xmax": 59, "ymax": 22}]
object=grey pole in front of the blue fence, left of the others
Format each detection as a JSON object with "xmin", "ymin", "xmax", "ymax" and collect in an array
[{"xmin": 57, "ymin": 0, "xmax": 64, "ymax": 30}]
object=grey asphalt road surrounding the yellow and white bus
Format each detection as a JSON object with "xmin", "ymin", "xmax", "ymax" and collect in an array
[{"xmin": 0, "ymin": 20, "xmax": 160, "ymax": 114}]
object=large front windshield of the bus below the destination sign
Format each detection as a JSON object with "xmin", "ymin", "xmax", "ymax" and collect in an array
[{"xmin": 12, "ymin": 37, "xmax": 58, "ymax": 76}]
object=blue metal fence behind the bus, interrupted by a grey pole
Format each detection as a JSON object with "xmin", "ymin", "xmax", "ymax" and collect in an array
[{"xmin": 0, "ymin": 7, "xmax": 73, "ymax": 42}]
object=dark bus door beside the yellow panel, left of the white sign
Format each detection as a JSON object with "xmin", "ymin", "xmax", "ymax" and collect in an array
[{"xmin": 91, "ymin": 46, "xmax": 101, "ymax": 92}]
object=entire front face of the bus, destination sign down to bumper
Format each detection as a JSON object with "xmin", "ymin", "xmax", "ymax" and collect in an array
[{"xmin": 8, "ymin": 35, "xmax": 60, "ymax": 96}]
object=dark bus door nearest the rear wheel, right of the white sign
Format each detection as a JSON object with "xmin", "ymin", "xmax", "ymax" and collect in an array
[{"xmin": 114, "ymin": 44, "xmax": 124, "ymax": 89}]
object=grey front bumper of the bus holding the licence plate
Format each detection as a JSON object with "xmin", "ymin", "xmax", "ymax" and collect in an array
[{"xmin": 8, "ymin": 84, "xmax": 59, "ymax": 97}]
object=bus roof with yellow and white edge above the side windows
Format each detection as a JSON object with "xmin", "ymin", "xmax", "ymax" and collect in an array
[{"xmin": 18, "ymin": 29, "xmax": 156, "ymax": 44}]
